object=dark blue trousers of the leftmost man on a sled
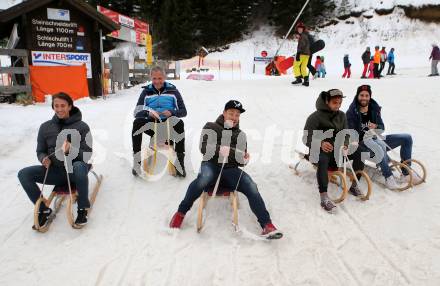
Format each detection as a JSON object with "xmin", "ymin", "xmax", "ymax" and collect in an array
[{"xmin": 18, "ymin": 161, "xmax": 90, "ymax": 209}]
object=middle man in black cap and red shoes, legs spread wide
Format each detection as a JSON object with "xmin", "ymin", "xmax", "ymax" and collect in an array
[{"xmin": 170, "ymin": 100, "xmax": 282, "ymax": 239}]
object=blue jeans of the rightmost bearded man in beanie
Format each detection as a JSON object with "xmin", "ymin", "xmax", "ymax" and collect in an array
[{"xmin": 359, "ymin": 134, "xmax": 412, "ymax": 178}]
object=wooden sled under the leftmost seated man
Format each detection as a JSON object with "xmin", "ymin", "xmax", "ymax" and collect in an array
[{"xmin": 32, "ymin": 170, "xmax": 103, "ymax": 233}]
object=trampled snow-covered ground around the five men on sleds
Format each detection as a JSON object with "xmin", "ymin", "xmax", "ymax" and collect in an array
[{"xmin": 0, "ymin": 65, "xmax": 440, "ymax": 286}]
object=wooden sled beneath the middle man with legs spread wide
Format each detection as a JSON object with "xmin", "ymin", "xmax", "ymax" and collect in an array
[{"xmin": 197, "ymin": 186, "xmax": 239, "ymax": 233}]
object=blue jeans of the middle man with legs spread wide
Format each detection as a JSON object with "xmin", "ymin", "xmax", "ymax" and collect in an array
[{"xmin": 179, "ymin": 161, "xmax": 271, "ymax": 227}]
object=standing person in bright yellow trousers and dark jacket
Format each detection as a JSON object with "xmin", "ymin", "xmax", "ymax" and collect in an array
[{"xmin": 292, "ymin": 23, "xmax": 310, "ymax": 86}]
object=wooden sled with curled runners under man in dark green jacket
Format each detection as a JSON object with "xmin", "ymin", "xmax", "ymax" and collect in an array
[{"xmin": 289, "ymin": 150, "xmax": 372, "ymax": 203}]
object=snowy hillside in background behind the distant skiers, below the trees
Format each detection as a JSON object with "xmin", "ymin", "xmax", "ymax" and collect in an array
[{"xmin": 208, "ymin": 8, "xmax": 440, "ymax": 77}]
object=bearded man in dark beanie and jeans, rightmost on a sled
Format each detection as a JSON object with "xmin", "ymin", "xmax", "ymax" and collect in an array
[{"xmin": 347, "ymin": 85, "xmax": 421, "ymax": 190}]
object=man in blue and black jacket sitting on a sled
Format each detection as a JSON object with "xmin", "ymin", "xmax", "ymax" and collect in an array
[{"xmin": 132, "ymin": 66, "xmax": 186, "ymax": 177}]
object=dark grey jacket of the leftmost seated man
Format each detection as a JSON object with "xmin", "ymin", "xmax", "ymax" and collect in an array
[{"xmin": 37, "ymin": 106, "xmax": 92, "ymax": 167}]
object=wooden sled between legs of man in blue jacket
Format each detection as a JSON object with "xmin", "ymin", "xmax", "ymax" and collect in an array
[{"xmin": 142, "ymin": 120, "xmax": 176, "ymax": 176}]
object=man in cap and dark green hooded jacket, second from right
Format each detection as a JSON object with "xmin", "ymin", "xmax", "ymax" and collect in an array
[{"xmin": 303, "ymin": 89, "xmax": 364, "ymax": 212}]
